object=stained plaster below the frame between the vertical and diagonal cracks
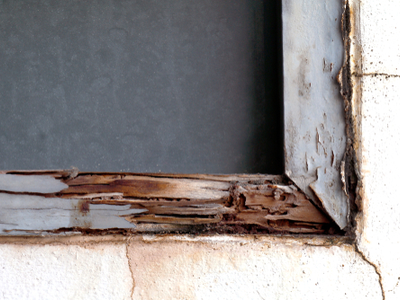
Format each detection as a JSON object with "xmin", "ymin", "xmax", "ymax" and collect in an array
[{"xmin": 129, "ymin": 238, "xmax": 381, "ymax": 299}]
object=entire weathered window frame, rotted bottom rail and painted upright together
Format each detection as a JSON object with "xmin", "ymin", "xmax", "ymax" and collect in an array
[{"xmin": 0, "ymin": 0, "xmax": 351, "ymax": 235}]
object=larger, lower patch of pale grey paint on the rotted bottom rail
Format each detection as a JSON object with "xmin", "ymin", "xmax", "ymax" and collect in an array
[{"xmin": 0, "ymin": 193, "xmax": 146, "ymax": 235}]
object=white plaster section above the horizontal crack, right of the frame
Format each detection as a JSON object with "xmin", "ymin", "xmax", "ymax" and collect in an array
[{"xmin": 357, "ymin": 0, "xmax": 400, "ymax": 75}]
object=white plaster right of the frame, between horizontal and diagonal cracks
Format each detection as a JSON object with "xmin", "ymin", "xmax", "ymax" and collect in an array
[{"xmin": 358, "ymin": 74, "xmax": 400, "ymax": 299}]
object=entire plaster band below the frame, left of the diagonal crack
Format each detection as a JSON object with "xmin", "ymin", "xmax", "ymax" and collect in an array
[{"xmin": 0, "ymin": 236, "xmax": 381, "ymax": 299}]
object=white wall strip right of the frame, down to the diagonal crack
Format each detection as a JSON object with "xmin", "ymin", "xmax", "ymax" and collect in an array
[{"xmin": 358, "ymin": 0, "xmax": 400, "ymax": 299}]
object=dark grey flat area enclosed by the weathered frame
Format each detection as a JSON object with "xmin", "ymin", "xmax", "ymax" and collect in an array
[{"xmin": 0, "ymin": 0, "xmax": 283, "ymax": 174}]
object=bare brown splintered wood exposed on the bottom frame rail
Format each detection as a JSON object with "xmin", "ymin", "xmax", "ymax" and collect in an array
[{"xmin": 0, "ymin": 170, "xmax": 337, "ymax": 234}]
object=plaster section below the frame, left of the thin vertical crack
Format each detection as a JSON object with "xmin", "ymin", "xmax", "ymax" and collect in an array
[{"xmin": 0, "ymin": 244, "xmax": 133, "ymax": 300}]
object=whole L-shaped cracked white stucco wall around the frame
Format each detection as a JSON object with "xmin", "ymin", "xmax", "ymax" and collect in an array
[{"xmin": 0, "ymin": 0, "xmax": 400, "ymax": 299}]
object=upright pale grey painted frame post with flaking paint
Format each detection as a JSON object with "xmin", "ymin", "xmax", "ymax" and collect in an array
[{"xmin": 282, "ymin": 0, "xmax": 349, "ymax": 228}]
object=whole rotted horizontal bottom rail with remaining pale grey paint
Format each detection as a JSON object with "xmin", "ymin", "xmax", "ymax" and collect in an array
[{"xmin": 0, "ymin": 170, "xmax": 337, "ymax": 235}]
